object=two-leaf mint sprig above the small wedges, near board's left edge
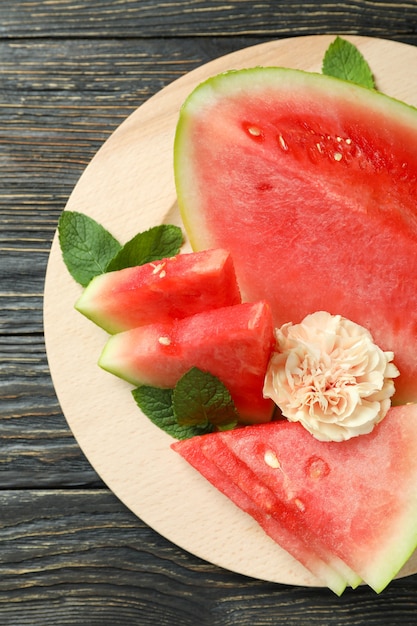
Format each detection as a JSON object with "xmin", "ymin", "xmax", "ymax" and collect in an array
[{"xmin": 58, "ymin": 211, "xmax": 183, "ymax": 287}]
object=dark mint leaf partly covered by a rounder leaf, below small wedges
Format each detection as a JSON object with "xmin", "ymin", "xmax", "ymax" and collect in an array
[{"xmin": 132, "ymin": 385, "xmax": 213, "ymax": 439}]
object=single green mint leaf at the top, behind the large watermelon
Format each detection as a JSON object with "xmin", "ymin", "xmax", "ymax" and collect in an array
[{"xmin": 322, "ymin": 37, "xmax": 375, "ymax": 89}]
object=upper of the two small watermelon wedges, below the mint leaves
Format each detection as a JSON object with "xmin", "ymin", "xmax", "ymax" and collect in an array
[{"xmin": 75, "ymin": 249, "xmax": 241, "ymax": 333}]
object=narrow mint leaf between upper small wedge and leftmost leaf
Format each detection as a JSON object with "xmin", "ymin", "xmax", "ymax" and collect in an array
[{"xmin": 106, "ymin": 224, "xmax": 183, "ymax": 272}]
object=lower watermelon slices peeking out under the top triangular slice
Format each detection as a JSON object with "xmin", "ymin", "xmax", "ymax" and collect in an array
[{"xmin": 172, "ymin": 436, "xmax": 346, "ymax": 595}]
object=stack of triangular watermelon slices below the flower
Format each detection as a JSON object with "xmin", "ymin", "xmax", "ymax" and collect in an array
[{"xmin": 172, "ymin": 404, "xmax": 417, "ymax": 592}]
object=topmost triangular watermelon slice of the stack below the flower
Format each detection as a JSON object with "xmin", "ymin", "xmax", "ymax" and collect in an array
[{"xmin": 173, "ymin": 404, "xmax": 417, "ymax": 593}]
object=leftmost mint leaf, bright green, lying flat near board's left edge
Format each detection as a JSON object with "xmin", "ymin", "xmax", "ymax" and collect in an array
[{"xmin": 58, "ymin": 211, "xmax": 122, "ymax": 287}]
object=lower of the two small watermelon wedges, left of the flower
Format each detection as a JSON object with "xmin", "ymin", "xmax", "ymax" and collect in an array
[{"xmin": 99, "ymin": 302, "xmax": 274, "ymax": 423}]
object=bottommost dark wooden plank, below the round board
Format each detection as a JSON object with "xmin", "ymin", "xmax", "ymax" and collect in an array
[{"xmin": 0, "ymin": 490, "xmax": 417, "ymax": 626}]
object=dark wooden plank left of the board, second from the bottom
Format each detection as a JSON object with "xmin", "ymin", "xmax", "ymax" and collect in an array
[{"xmin": 0, "ymin": 336, "xmax": 102, "ymax": 490}]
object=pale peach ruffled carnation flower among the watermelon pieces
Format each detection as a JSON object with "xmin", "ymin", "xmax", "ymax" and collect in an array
[{"xmin": 264, "ymin": 311, "xmax": 399, "ymax": 441}]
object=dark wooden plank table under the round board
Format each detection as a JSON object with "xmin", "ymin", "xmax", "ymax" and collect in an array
[{"xmin": 0, "ymin": 0, "xmax": 417, "ymax": 626}]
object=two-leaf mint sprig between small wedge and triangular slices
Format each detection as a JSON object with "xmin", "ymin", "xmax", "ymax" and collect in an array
[{"xmin": 132, "ymin": 367, "xmax": 239, "ymax": 439}]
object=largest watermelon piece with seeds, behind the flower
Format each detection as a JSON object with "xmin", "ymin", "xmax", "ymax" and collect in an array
[{"xmin": 175, "ymin": 68, "xmax": 417, "ymax": 404}]
